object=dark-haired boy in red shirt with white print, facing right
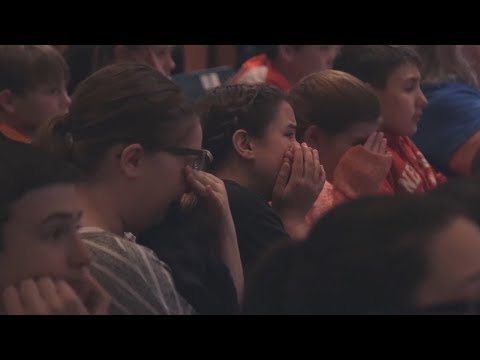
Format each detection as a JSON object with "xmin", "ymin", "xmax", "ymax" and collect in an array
[{"xmin": 334, "ymin": 45, "xmax": 446, "ymax": 193}]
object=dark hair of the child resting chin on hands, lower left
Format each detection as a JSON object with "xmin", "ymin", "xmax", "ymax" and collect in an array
[{"xmin": 0, "ymin": 141, "xmax": 80, "ymax": 246}]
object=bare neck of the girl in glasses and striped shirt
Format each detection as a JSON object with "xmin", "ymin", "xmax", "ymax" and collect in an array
[{"xmin": 77, "ymin": 183, "xmax": 126, "ymax": 236}]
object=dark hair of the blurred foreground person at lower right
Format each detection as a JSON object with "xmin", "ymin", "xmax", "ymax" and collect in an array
[{"xmin": 249, "ymin": 195, "xmax": 465, "ymax": 314}]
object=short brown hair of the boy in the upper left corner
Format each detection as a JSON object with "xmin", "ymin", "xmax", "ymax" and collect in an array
[{"xmin": 0, "ymin": 45, "xmax": 69, "ymax": 94}]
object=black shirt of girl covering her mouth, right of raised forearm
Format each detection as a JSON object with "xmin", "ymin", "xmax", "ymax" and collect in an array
[{"xmin": 224, "ymin": 180, "xmax": 290, "ymax": 278}]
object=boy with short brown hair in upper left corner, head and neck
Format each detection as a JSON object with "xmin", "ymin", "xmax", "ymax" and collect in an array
[{"xmin": 0, "ymin": 45, "xmax": 70, "ymax": 143}]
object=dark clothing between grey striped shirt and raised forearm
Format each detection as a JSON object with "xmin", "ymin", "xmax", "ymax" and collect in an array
[{"xmin": 137, "ymin": 213, "xmax": 240, "ymax": 315}]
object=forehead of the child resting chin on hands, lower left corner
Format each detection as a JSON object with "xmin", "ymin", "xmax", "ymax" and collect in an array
[{"xmin": 11, "ymin": 184, "xmax": 80, "ymax": 222}]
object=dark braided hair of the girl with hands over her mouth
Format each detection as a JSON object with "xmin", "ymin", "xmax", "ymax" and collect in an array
[{"xmin": 198, "ymin": 84, "xmax": 285, "ymax": 170}]
